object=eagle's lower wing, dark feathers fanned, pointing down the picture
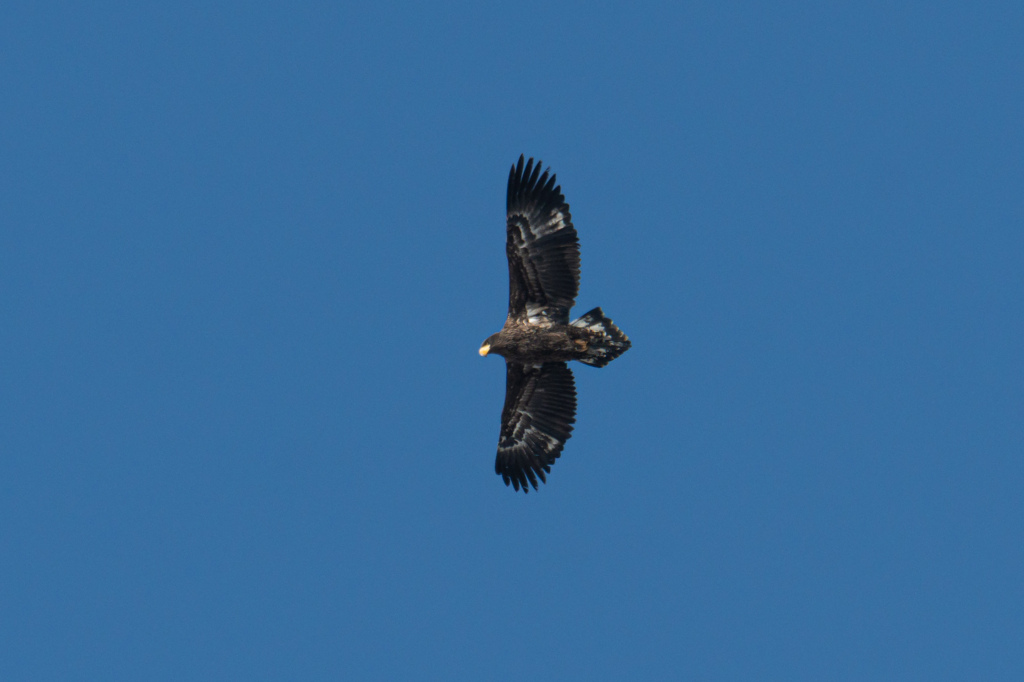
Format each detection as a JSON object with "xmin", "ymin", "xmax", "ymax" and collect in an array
[{"xmin": 495, "ymin": 363, "xmax": 575, "ymax": 493}]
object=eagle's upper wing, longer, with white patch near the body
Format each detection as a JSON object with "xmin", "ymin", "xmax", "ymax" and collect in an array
[{"xmin": 505, "ymin": 156, "xmax": 580, "ymax": 325}]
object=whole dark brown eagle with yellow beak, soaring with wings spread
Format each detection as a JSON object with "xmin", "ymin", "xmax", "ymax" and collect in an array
[{"xmin": 479, "ymin": 156, "xmax": 631, "ymax": 493}]
